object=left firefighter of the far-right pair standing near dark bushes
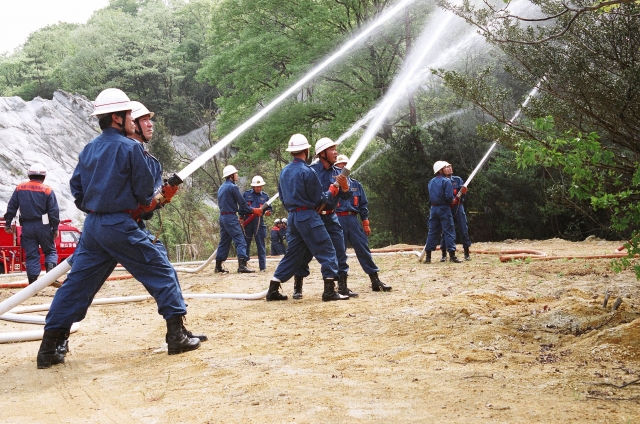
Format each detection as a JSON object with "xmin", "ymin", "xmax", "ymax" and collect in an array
[{"xmin": 424, "ymin": 160, "xmax": 462, "ymax": 263}]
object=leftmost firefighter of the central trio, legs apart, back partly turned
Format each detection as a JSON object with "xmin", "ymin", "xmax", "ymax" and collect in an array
[{"xmin": 267, "ymin": 134, "xmax": 349, "ymax": 302}]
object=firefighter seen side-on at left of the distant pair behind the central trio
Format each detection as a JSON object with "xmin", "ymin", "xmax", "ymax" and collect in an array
[{"xmin": 214, "ymin": 165, "xmax": 262, "ymax": 274}]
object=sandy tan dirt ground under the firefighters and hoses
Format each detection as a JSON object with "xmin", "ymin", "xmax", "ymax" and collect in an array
[{"xmin": 0, "ymin": 239, "xmax": 640, "ymax": 423}]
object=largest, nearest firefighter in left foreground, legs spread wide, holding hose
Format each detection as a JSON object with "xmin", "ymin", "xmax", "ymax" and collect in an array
[{"xmin": 37, "ymin": 88, "xmax": 200, "ymax": 368}]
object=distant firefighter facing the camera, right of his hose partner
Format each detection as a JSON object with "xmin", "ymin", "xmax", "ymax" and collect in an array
[{"xmin": 242, "ymin": 175, "xmax": 272, "ymax": 271}]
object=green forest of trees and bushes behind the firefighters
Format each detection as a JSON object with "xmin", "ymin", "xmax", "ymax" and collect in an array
[{"xmin": 0, "ymin": 0, "xmax": 640, "ymax": 264}]
